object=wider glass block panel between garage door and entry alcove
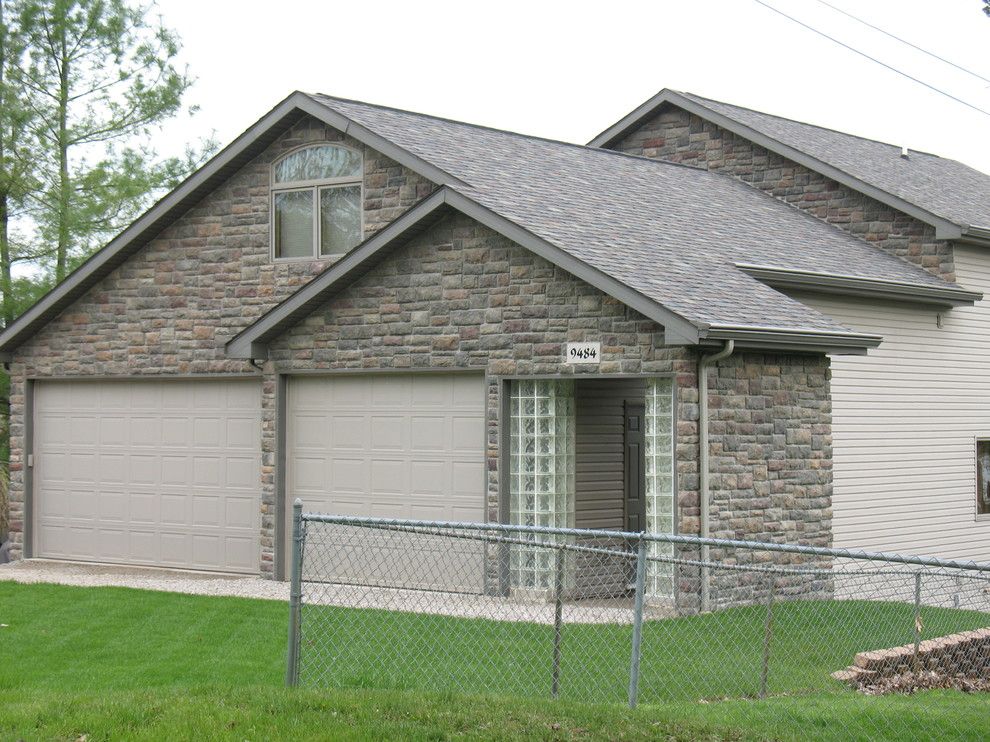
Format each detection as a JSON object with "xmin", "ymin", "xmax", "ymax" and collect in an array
[{"xmin": 509, "ymin": 379, "xmax": 575, "ymax": 590}]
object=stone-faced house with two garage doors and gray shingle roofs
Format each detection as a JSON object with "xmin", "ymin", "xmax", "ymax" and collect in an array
[{"xmin": 0, "ymin": 91, "xmax": 990, "ymax": 602}]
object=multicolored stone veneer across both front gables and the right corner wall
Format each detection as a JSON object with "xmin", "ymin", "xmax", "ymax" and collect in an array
[{"xmin": 5, "ymin": 112, "xmax": 831, "ymax": 604}]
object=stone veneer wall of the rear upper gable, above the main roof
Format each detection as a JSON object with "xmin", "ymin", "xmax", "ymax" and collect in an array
[{"xmin": 610, "ymin": 104, "xmax": 955, "ymax": 281}]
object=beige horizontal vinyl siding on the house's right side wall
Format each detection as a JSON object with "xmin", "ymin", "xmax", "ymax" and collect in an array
[{"xmin": 798, "ymin": 247, "xmax": 990, "ymax": 561}]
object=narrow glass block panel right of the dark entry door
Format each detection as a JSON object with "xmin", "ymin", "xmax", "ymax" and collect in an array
[{"xmin": 645, "ymin": 379, "xmax": 676, "ymax": 598}]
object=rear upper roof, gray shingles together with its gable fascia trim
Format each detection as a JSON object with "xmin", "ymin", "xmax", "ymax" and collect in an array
[{"xmin": 589, "ymin": 90, "xmax": 990, "ymax": 239}]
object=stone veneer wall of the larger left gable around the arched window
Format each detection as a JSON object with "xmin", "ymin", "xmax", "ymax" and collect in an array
[{"xmin": 2, "ymin": 118, "xmax": 433, "ymax": 557}]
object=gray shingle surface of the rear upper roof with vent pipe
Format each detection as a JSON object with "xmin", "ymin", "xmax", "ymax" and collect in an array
[{"xmin": 679, "ymin": 92, "xmax": 990, "ymax": 228}]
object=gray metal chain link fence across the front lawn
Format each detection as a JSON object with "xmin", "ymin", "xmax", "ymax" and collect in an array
[{"xmin": 286, "ymin": 502, "xmax": 990, "ymax": 739}]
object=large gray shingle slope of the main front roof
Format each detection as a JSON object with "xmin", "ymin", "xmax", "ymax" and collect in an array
[{"xmin": 314, "ymin": 95, "xmax": 968, "ymax": 333}]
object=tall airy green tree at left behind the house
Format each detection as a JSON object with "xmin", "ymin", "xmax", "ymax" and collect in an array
[{"xmin": 0, "ymin": 0, "xmax": 215, "ymax": 535}]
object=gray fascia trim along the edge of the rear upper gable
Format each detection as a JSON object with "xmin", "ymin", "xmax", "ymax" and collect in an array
[{"xmin": 588, "ymin": 89, "xmax": 963, "ymax": 240}]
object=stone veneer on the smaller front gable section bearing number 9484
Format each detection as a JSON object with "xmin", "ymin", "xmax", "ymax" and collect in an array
[{"xmin": 263, "ymin": 216, "xmax": 831, "ymax": 601}]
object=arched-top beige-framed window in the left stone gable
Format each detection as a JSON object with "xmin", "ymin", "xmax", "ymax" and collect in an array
[{"xmin": 272, "ymin": 144, "xmax": 363, "ymax": 259}]
